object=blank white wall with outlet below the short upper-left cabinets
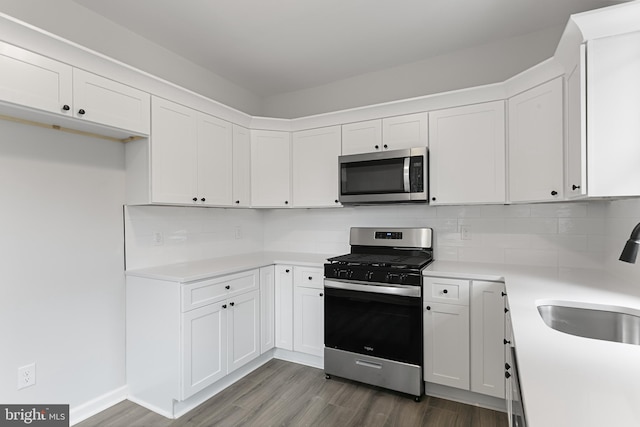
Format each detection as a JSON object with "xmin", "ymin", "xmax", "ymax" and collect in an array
[{"xmin": 0, "ymin": 121, "xmax": 126, "ymax": 418}]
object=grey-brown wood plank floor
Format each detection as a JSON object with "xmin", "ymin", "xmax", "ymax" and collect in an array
[{"xmin": 76, "ymin": 359, "xmax": 508, "ymax": 427}]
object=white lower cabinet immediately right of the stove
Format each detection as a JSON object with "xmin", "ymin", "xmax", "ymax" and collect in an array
[{"xmin": 423, "ymin": 277, "xmax": 504, "ymax": 399}]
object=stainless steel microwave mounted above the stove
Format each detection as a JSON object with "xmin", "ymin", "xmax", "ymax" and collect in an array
[{"xmin": 338, "ymin": 147, "xmax": 429, "ymax": 204}]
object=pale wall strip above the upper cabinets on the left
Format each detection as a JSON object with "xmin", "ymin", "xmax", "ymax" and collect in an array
[{"xmin": 0, "ymin": 0, "xmax": 262, "ymax": 115}]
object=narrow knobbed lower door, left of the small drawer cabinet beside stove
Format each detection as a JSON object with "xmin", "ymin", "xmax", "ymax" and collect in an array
[{"xmin": 275, "ymin": 265, "xmax": 293, "ymax": 351}]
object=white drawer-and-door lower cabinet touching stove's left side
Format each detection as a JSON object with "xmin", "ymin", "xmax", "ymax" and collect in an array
[{"xmin": 293, "ymin": 267, "xmax": 324, "ymax": 357}]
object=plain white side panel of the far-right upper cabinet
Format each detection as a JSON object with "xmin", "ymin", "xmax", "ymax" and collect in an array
[{"xmin": 582, "ymin": 31, "xmax": 640, "ymax": 197}]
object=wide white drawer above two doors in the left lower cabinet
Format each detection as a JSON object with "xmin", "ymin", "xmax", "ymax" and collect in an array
[{"xmin": 182, "ymin": 270, "xmax": 259, "ymax": 311}]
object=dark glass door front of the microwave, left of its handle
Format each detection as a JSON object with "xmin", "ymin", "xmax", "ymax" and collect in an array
[{"xmin": 340, "ymin": 157, "xmax": 407, "ymax": 196}]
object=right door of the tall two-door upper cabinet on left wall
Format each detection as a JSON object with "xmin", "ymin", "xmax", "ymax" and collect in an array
[{"xmin": 197, "ymin": 113, "xmax": 233, "ymax": 206}]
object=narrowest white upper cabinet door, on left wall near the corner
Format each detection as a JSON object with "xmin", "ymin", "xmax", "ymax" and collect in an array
[{"xmin": 232, "ymin": 125, "xmax": 251, "ymax": 207}]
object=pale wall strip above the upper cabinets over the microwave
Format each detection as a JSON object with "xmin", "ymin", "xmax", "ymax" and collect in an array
[{"xmin": 263, "ymin": 27, "xmax": 564, "ymax": 118}]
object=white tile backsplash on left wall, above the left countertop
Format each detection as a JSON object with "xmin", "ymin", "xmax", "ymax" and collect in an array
[{"xmin": 125, "ymin": 206, "xmax": 263, "ymax": 270}]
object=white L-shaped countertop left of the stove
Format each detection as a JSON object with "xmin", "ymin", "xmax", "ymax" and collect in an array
[{"xmin": 125, "ymin": 252, "xmax": 333, "ymax": 283}]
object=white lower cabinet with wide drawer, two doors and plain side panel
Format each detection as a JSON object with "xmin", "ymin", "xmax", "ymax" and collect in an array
[{"xmin": 126, "ymin": 269, "xmax": 262, "ymax": 416}]
